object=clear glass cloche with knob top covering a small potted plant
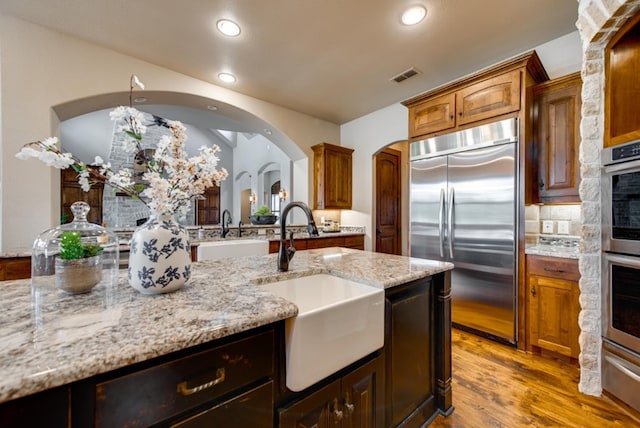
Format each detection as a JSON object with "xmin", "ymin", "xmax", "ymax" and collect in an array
[{"xmin": 31, "ymin": 202, "xmax": 119, "ymax": 294}]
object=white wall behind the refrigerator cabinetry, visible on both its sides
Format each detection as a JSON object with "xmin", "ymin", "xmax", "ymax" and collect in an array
[{"xmin": 340, "ymin": 31, "xmax": 582, "ymax": 249}]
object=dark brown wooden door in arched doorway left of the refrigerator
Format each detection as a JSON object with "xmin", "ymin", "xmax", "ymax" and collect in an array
[{"xmin": 376, "ymin": 149, "xmax": 402, "ymax": 254}]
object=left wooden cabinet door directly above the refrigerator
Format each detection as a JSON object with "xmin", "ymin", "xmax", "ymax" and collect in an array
[{"xmin": 409, "ymin": 94, "xmax": 456, "ymax": 135}]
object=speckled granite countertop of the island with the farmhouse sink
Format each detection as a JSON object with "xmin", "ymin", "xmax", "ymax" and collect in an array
[{"xmin": 0, "ymin": 247, "xmax": 453, "ymax": 402}]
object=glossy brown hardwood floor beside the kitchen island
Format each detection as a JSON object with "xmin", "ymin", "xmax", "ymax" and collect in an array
[{"xmin": 430, "ymin": 329, "xmax": 640, "ymax": 428}]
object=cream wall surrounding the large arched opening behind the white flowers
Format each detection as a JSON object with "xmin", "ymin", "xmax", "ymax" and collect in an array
[{"xmin": 0, "ymin": 15, "xmax": 340, "ymax": 252}]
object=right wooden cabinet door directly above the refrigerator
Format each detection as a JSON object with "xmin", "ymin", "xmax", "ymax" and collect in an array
[{"xmin": 456, "ymin": 70, "xmax": 520, "ymax": 125}]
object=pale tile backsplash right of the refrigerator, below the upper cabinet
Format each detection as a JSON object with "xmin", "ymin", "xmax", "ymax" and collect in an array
[{"xmin": 524, "ymin": 204, "xmax": 580, "ymax": 243}]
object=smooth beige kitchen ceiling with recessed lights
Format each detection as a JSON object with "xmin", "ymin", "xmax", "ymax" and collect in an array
[{"xmin": 0, "ymin": 0, "xmax": 578, "ymax": 124}]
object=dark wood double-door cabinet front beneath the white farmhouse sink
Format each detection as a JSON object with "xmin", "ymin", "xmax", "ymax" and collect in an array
[{"xmin": 278, "ymin": 355, "xmax": 385, "ymax": 428}]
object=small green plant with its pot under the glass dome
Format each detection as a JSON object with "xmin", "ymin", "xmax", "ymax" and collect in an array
[{"xmin": 55, "ymin": 231, "xmax": 103, "ymax": 294}]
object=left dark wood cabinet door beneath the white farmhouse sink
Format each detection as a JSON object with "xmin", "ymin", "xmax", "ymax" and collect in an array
[{"xmin": 278, "ymin": 380, "xmax": 341, "ymax": 428}]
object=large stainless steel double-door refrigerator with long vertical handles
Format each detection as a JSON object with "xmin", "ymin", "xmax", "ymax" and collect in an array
[{"xmin": 410, "ymin": 119, "xmax": 518, "ymax": 344}]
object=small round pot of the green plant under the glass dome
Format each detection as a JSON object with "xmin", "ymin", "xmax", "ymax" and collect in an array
[{"xmin": 55, "ymin": 256, "xmax": 102, "ymax": 294}]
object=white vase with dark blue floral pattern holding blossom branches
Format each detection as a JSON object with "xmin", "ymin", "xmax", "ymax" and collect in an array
[{"xmin": 129, "ymin": 214, "xmax": 191, "ymax": 294}]
